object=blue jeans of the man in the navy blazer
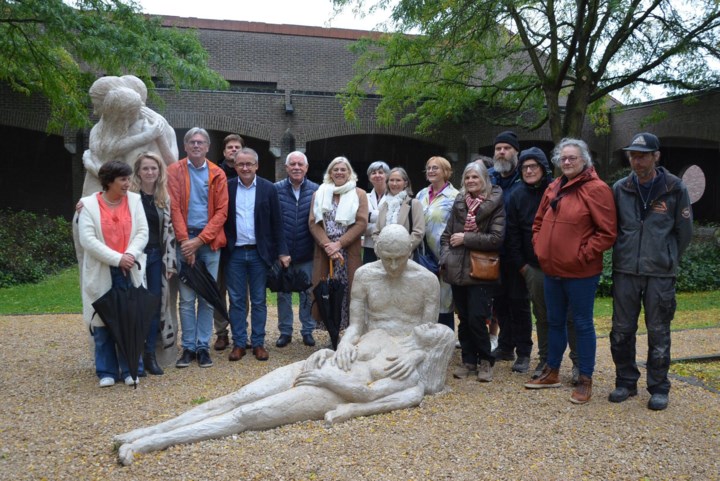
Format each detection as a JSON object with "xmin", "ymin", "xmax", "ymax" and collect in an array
[{"xmin": 225, "ymin": 247, "xmax": 269, "ymax": 348}]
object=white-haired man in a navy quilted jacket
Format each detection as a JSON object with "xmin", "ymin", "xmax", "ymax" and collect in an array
[{"xmin": 275, "ymin": 151, "xmax": 318, "ymax": 347}]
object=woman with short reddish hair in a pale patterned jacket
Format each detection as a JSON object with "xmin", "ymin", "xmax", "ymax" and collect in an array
[{"xmin": 417, "ymin": 156, "xmax": 458, "ymax": 330}]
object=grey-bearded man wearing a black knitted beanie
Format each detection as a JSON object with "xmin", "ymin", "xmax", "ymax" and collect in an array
[{"xmin": 490, "ymin": 130, "xmax": 535, "ymax": 373}]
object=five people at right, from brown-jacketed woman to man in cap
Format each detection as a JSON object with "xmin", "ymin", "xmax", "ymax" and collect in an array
[{"xmin": 440, "ymin": 131, "xmax": 692, "ymax": 410}]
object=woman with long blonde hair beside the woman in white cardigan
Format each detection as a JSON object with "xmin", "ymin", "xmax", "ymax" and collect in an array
[{"xmin": 130, "ymin": 152, "xmax": 177, "ymax": 375}]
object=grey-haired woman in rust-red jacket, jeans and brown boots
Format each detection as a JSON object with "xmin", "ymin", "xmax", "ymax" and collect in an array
[{"xmin": 525, "ymin": 139, "xmax": 617, "ymax": 404}]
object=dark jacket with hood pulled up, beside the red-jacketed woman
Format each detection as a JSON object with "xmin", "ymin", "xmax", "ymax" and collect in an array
[{"xmin": 505, "ymin": 147, "xmax": 553, "ymax": 271}]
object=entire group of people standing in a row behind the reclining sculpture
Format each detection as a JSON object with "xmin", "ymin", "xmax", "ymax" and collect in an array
[{"xmin": 79, "ymin": 120, "xmax": 692, "ymax": 409}]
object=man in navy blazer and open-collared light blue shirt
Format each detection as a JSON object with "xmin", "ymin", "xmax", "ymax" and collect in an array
[{"xmin": 223, "ymin": 147, "xmax": 291, "ymax": 361}]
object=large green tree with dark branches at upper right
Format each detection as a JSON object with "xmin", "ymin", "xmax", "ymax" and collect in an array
[{"xmin": 333, "ymin": 0, "xmax": 720, "ymax": 141}]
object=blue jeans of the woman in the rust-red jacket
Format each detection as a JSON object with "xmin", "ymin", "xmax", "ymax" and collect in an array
[{"xmin": 545, "ymin": 274, "xmax": 600, "ymax": 377}]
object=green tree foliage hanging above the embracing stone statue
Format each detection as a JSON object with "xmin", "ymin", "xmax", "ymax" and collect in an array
[{"xmin": 0, "ymin": 0, "xmax": 227, "ymax": 131}]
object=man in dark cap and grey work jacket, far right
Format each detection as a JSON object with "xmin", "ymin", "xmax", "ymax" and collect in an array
[{"xmin": 609, "ymin": 133, "xmax": 692, "ymax": 410}]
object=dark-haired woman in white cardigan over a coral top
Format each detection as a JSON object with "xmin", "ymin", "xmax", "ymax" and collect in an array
[{"xmin": 78, "ymin": 161, "xmax": 148, "ymax": 387}]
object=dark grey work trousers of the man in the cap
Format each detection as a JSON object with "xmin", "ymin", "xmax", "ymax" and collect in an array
[{"xmin": 610, "ymin": 272, "xmax": 676, "ymax": 394}]
